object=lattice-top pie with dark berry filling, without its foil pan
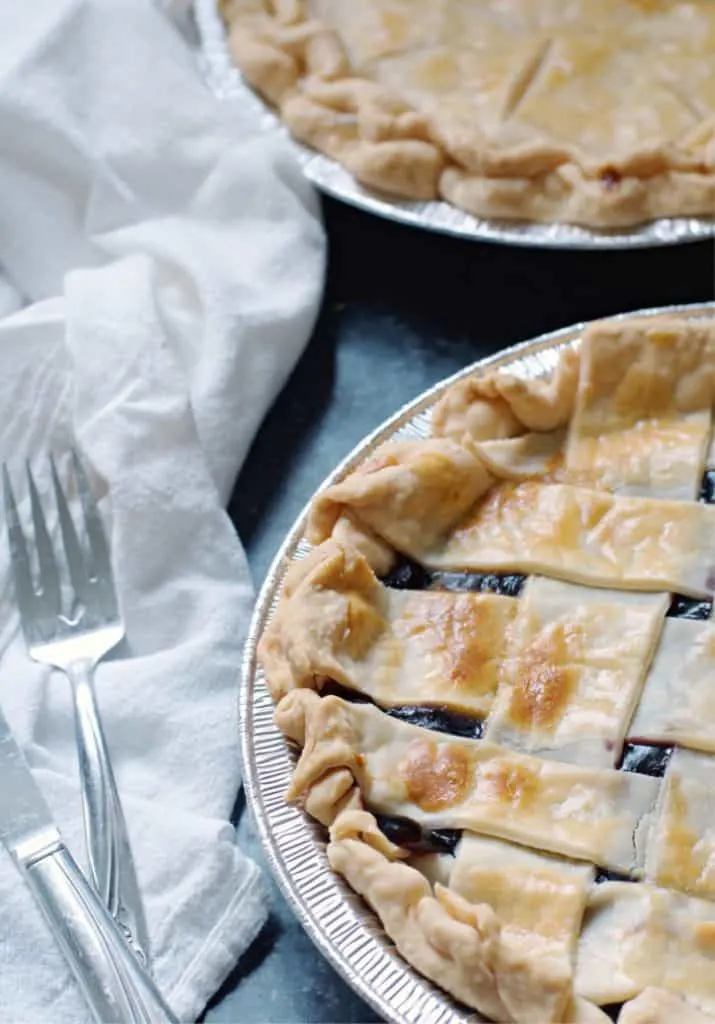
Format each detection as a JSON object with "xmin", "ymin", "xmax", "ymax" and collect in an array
[{"xmin": 259, "ymin": 317, "xmax": 715, "ymax": 1024}]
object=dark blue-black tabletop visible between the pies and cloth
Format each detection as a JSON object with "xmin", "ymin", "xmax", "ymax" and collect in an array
[{"xmin": 206, "ymin": 202, "xmax": 715, "ymax": 1024}]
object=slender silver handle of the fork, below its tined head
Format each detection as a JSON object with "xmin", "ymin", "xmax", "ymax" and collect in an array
[{"xmin": 66, "ymin": 660, "xmax": 149, "ymax": 966}]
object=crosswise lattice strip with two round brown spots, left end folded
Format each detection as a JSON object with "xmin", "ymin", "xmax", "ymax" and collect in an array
[{"xmin": 276, "ymin": 690, "xmax": 660, "ymax": 874}]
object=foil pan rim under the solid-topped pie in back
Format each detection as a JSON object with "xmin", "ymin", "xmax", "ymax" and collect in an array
[{"xmin": 194, "ymin": 0, "xmax": 715, "ymax": 250}]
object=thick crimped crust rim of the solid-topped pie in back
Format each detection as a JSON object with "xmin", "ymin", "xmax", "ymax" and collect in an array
[{"xmin": 223, "ymin": 0, "xmax": 715, "ymax": 227}]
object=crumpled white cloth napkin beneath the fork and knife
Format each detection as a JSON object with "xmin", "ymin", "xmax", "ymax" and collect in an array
[{"xmin": 0, "ymin": 0, "xmax": 324, "ymax": 1024}]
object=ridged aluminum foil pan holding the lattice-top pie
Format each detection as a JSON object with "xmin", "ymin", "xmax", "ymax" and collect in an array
[{"xmin": 240, "ymin": 302, "xmax": 715, "ymax": 1024}]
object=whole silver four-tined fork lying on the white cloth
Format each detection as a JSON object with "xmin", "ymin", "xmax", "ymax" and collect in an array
[{"xmin": 2, "ymin": 451, "xmax": 149, "ymax": 967}]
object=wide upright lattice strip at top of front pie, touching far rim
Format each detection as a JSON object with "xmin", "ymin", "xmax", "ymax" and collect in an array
[{"xmin": 566, "ymin": 319, "xmax": 715, "ymax": 501}]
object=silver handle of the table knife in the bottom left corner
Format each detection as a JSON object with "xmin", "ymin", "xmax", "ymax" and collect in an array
[{"xmin": 16, "ymin": 843, "xmax": 176, "ymax": 1024}]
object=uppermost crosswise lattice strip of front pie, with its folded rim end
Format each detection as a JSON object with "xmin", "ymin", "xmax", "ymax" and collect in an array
[{"xmin": 309, "ymin": 439, "xmax": 715, "ymax": 597}]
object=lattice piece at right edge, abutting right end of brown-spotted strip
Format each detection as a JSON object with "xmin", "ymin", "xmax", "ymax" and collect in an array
[{"xmin": 646, "ymin": 750, "xmax": 715, "ymax": 901}]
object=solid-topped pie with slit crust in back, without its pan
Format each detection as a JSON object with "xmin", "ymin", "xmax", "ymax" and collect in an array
[{"xmin": 221, "ymin": 0, "xmax": 715, "ymax": 228}]
